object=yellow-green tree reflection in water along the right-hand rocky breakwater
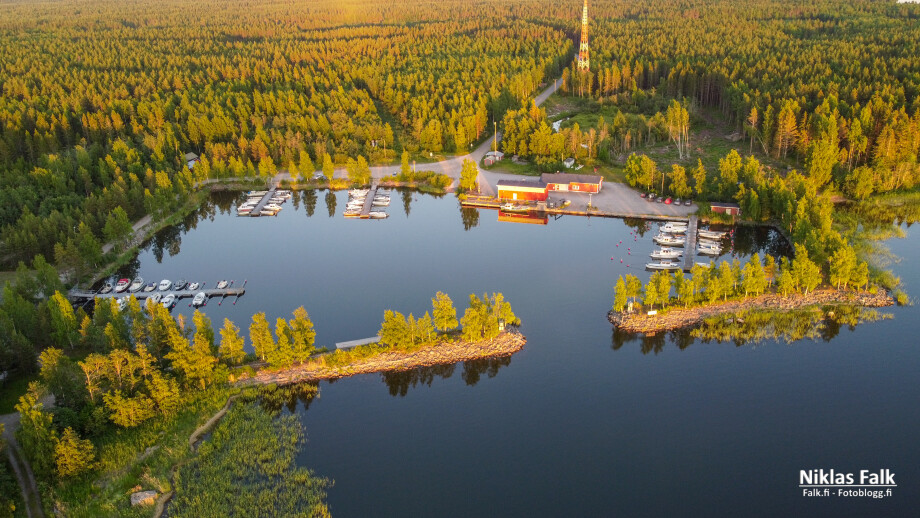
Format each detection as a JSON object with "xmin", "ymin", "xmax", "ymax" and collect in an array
[{"xmin": 611, "ymin": 306, "xmax": 891, "ymax": 354}]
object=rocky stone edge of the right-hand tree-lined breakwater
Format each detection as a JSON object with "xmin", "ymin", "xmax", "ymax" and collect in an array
[{"xmin": 607, "ymin": 288, "xmax": 895, "ymax": 334}]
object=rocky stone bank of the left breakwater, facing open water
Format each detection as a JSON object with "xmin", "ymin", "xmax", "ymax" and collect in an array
[{"xmin": 237, "ymin": 331, "xmax": 527, "ymax": 386}]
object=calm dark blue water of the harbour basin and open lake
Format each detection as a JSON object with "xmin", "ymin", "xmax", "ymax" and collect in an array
[{"xmin": 113, "ymin": 192, "xmax": 920, "ymax": 517}]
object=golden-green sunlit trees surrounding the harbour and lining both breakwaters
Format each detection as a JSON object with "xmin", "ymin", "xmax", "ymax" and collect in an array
[{"xmin": 0, "ymin": 0, "xmax": 920, "ymax": 516}]
